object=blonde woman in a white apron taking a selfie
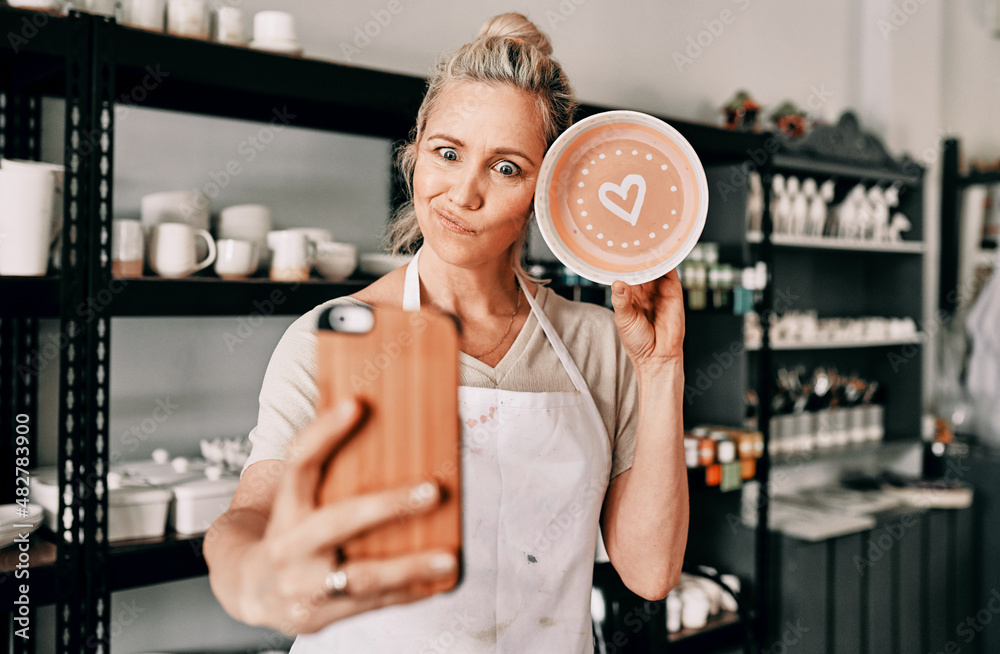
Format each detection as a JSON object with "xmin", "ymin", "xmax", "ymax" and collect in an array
[{"xmin": 205, "ymin": 14, "xmax": 688, "ymax": 654}]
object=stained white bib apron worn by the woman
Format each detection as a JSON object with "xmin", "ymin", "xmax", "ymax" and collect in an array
[{"xmin": 292, "ymin": 252, "xmax": 611, "ymax": 654}]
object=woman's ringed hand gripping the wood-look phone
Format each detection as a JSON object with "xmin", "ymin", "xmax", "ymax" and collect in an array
[{"xmin": 232, "ymin": 400, "xmax": 458, "ymax": 635}]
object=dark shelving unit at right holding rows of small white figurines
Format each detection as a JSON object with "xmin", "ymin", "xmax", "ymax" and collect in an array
[{"xmin": 684, "ymin": 114, "xmax": 925, "ymax": 651}]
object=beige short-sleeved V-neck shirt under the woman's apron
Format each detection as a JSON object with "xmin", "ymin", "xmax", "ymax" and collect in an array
[{"xmin": 243, "ymin": 286, "xmax": 638, "ymax": 477}]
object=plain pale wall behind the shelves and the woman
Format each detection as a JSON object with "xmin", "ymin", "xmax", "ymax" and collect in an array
[{"xmin": 33, "ymin": 0, "xmax": 1000, "ymax": 652}]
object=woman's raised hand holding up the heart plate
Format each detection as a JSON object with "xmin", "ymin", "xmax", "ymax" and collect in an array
[{"xmin": 611, "ymin": 270, "xmax": 684, "ymax": 376}]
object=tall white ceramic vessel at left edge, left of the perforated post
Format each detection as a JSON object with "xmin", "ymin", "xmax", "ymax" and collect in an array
[{"xmin": 0, "ymin": 168, "xmax": 55, "ymax": 277}]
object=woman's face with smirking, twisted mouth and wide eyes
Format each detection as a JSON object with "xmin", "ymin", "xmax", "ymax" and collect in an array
[{"xmin": 413, "ymin": 82, "xmax": 545, "ymax": 267}]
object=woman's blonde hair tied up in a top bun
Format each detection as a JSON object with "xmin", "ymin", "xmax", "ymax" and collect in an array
[{"xmin": 383, "ymin": 13, "xmax": 577, "ymax": 281}]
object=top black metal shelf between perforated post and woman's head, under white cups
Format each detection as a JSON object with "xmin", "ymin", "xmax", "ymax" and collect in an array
[{"xmin": 109, "ymin": 25, "xmax": 426, "ymax": 139}]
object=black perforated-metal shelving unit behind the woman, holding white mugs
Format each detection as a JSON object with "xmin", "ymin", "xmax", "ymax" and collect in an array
[{"xmin": 0, "ymin": 7, "xmax": 766, "ymax": 652}]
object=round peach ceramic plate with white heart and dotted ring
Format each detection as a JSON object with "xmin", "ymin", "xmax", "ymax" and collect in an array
[{"xmin": 535, "ymin": 111, "xmax": 708, "ymax": 284}]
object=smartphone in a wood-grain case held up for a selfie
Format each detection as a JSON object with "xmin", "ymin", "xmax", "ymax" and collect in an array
[{"xmin": 316, "ymin": 305, "xmax": 462, "ymax": 593}]
